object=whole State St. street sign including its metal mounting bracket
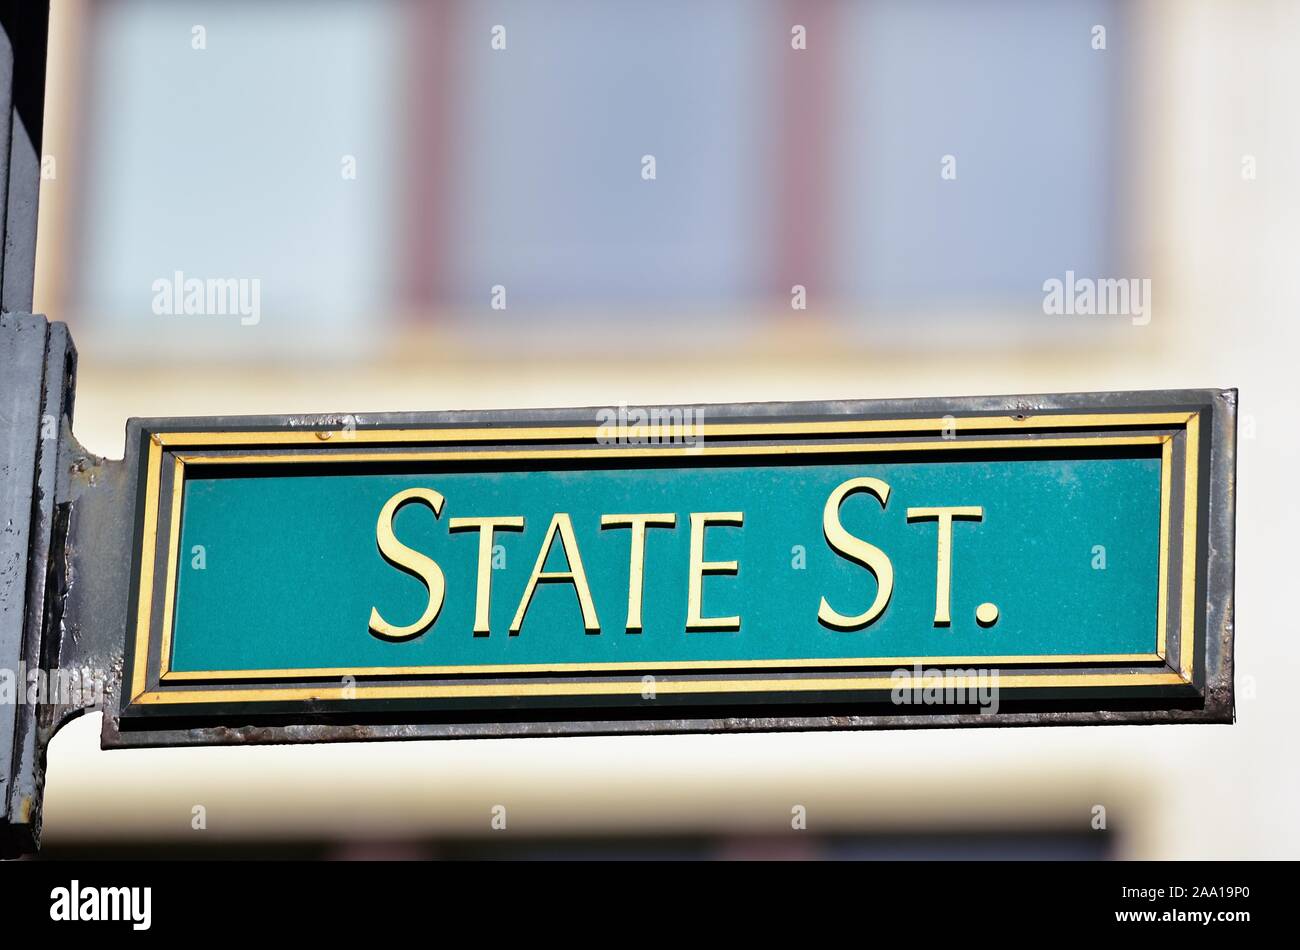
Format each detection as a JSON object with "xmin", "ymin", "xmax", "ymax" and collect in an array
[{"xmin": 0, "ymin": 317, "xmax": 1236, "ymax": 852}]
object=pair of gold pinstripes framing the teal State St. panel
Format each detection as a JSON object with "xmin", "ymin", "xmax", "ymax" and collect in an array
[{"xmin": 131, "ymin": 412, "xmax": 1197, "ymax": 703}]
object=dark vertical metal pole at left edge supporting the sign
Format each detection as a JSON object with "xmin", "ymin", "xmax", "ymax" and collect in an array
[{"xmin": 0, "ymin": 0, "xmax": 56, "ymax": 856}]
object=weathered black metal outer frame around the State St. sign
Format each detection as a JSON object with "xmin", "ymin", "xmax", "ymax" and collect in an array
[{"xmin": 86, "ymin": 390, "xmax": 1235, "ymax": 746}]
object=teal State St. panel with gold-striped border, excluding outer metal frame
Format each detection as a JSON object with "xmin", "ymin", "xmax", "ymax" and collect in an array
[{"xmin": 134, "ymin": 421, "xmax": 1199, "ymax": 716}]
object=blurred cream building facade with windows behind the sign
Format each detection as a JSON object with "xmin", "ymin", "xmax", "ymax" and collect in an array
[{"xmin": 22, "ymin": 0, "xmax": 1300, "ymax": 858}]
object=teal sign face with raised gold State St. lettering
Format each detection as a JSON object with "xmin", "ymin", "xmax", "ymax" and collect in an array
[{"xmin": 170, "ymin": 456, "xmax": 1161, "ymax": 676}]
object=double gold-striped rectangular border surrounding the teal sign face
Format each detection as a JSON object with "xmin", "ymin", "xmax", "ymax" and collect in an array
[{"xmin": 122, "ymin": 400, "xmax": 1205, "ymax": 715}]
